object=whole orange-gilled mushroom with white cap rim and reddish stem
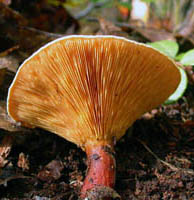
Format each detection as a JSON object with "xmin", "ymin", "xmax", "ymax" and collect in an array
[{"xmin": 7, "ymin": 35, "xmax": 180, "ymax": 199}]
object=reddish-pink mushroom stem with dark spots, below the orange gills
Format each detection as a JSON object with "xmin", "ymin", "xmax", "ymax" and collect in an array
[{"xmin": 81, "ymin": 145, "xmax": 116, "ymax": 199}]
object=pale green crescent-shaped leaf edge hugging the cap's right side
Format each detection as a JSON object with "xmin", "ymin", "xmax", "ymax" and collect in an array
[{"xmin": 164, "ymin": 67, "xmax": 188, "ymax": 104}]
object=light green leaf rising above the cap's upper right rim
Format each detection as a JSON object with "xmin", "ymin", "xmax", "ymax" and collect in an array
[{"xmin": 148, "ymin": 40, "xmax": 179, "ymax": 58}]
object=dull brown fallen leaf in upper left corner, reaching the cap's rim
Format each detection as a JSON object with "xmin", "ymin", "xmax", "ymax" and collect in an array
[{"xmin": 0, "ymin": 2, "xmax": 61, "ymax": 59}]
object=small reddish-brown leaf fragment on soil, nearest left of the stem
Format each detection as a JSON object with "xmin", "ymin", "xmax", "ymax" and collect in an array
[{"xmin": 37, "ymin": 160, "xmax": 64, "ymax": 182}]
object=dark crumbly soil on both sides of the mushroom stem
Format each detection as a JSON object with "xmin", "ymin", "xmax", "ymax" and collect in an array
[{"xmin": 0, "ymin": 79, "xmax": 194, "ymax": 200}]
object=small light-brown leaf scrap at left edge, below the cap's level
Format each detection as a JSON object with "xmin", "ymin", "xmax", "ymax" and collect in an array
[{"xmin": 0, "ymin": 135, "xmax": 13, "ymax": 168}]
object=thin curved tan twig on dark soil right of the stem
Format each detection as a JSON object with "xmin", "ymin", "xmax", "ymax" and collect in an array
[{"xmin": 136, "ymin": 138, "xmax": 194, "ymax": 175}]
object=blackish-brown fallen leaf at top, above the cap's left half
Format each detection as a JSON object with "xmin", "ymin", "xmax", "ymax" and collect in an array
[{"xmin": 12, "ymin": 0, "xmax": 79, "ymax": 33}]
